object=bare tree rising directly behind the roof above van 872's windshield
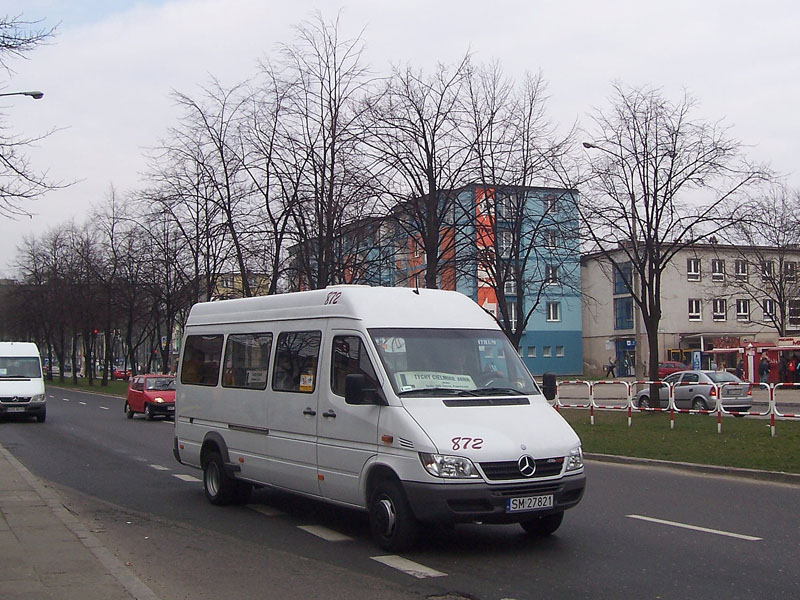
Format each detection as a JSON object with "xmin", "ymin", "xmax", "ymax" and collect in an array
[{"xmin": 366, "ymin": 55, "xmax": 472, "ymax": 288}]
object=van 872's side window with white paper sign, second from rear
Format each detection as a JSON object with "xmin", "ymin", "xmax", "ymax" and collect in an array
[{"xmin": 222, "ymin": 333, "xmax": 272, "ymax": 390}]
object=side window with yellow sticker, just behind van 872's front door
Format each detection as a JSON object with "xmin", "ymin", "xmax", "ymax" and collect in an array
[{"xmin": 272, "ymin": 331, "xmax": 322, "ymax": 394}]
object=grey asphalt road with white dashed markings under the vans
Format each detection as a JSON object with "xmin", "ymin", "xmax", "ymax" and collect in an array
[{"xmin": 0, "ymin": 388, "xmax": 800, "ymax": 600}]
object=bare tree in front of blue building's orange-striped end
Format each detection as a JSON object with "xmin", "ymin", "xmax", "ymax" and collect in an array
[{"xmin": 458, "ymin": 64, "xmax": 580, "ymax": 345}]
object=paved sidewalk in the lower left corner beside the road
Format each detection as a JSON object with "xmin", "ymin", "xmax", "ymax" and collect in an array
[{"xmin": 0, "ymin": 444, "xmax": 158, "ymax": 600}]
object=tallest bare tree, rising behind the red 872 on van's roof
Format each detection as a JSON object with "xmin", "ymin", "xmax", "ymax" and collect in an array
[{"xmin": 281, "ymin": 16, "xmax": 378, "ymax": 289}]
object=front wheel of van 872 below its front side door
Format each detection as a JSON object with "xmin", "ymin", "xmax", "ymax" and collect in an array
[{"xmin": 369, "ymin": 480, "xmax": 419, "ymax": 552}]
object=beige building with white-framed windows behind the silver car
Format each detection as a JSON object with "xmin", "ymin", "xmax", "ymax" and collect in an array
[{"xmin": 581, "ymin": 244, "xmax": 800, "ymax": 378}]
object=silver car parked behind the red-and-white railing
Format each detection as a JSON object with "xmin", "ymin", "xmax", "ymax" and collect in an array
[{"xmin": 635, "ymin": 371, "xmax": 753, "ymax": 416}]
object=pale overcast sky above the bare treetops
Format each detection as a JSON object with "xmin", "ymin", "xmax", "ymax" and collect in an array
[{"xmin": 0, "ymin": 0, "xmax": 800, "ymax": 275}]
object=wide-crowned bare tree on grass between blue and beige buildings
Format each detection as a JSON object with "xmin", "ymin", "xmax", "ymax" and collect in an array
[{"xmin": 578, "ymin": 84, "xmax": 768, "ymax": 380}]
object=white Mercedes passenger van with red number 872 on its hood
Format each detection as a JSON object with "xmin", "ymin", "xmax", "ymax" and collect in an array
[{"xmin": 174, "ymin": 286, "xmax": 585, "ymax": 551}]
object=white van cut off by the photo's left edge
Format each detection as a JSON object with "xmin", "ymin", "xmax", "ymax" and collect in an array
[{"xmin": 0, "ymin": 342, "xmax": 47, "ymax": 423}]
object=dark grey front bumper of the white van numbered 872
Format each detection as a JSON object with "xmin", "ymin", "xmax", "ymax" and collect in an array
[{"xmin": 403, "ymin": 472, "xmax": 586, "ymax": 523}]
